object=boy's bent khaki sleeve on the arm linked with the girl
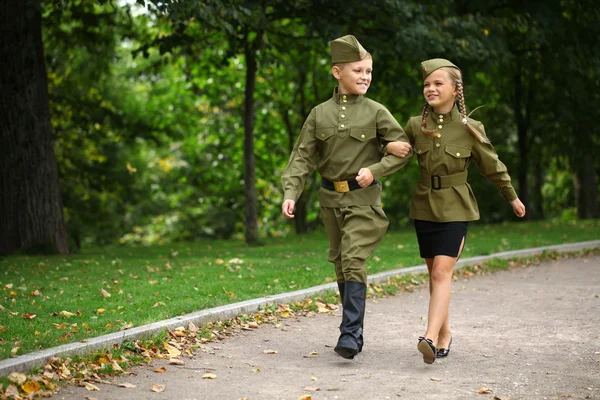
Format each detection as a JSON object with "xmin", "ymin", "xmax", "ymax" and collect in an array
[{"xmin": 368, "ymin": 108, "xmax": 413, "ymax": 179}]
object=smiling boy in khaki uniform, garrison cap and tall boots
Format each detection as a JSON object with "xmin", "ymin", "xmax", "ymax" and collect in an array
[{"xmin": 281, "ymin": 35, "xmax": 412, "ymax": 359}]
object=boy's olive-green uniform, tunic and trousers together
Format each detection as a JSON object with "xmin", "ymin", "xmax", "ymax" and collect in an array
[{"xmin": 281, "ymin": 90, "xmax": 410, "ymax": 283}]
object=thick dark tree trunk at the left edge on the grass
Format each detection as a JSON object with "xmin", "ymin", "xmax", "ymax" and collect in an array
[{"xmin": 0, "ymin": 0, "xmax": 69, "ymax": 255}]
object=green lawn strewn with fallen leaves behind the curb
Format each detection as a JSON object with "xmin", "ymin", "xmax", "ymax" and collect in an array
[{"xmin": 0, "ymin": 220, "xmax": 600, "ymax": 359}]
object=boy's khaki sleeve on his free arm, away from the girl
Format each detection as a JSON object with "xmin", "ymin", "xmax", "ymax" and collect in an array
[{"xmin": 281, "ymin": 108, "xmax": 317, "ymax": 201}]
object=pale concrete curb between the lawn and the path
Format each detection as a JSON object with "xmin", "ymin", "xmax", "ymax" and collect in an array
[{"xmin": 0, "ymin": 240, "xmax": 600, "ymax": 376}]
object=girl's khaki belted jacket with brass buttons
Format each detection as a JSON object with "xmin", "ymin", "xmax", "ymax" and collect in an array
[{"xmin": 405, "ymin": 106, "xmax": 517, "ymax": 222}]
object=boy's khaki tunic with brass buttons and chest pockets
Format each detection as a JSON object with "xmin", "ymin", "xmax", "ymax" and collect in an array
[{"xmin": 281, "ymin": 88, "xmax": 410, "ymax": 207}]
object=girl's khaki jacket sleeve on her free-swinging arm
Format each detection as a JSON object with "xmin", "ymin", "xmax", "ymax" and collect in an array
[{"xmin": 470, "ymin": 120, "xmax": 517, "ymax": 201}]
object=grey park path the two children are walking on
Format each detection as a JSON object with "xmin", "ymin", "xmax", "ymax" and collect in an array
[{"xmin": 54, "ymin": 256, "xmax": 600, "ymax": 400}]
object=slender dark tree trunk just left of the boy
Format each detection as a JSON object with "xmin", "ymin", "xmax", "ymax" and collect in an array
[{"xmin": 244, "ymin": 36, "xmax": 261, "ymax": 244}]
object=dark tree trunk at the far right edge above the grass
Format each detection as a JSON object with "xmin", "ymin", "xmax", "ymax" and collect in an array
[{"xmin": 575, "ymin": 155, "xmax": 598, "ymax": 219}]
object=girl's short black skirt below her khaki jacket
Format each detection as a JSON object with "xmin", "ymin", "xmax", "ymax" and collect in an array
[{"xmin": 415, "ymin": 219, "xmax": 469, "ymax": 258}]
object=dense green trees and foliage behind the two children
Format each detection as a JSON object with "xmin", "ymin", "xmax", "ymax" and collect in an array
[{"xmin": 0, "ymin": 0, "xmax": 600, "ymax": 253}]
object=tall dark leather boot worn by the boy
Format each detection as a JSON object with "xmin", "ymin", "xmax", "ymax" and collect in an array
[{"xmin": 334, "ymin": 281, "xmax": 367, "ymax": 359}]
